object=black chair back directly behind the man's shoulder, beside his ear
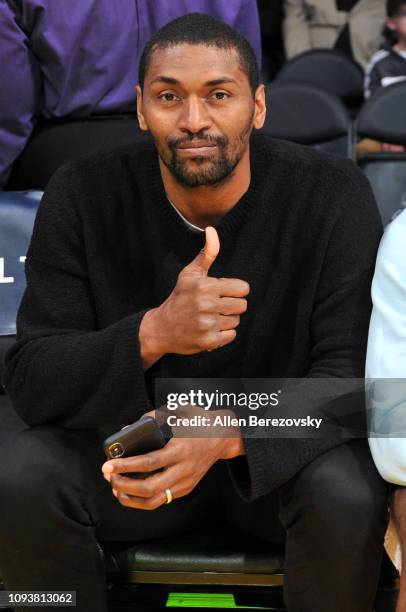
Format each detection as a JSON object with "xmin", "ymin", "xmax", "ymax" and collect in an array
[{"xmin": 264, "ymin": 81, "xmax": 354, "ymax": 157}]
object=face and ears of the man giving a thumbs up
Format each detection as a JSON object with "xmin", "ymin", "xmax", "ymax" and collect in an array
[{"xmin": 137, "ymin": 44, "xmax": 265, "ymax": 188}]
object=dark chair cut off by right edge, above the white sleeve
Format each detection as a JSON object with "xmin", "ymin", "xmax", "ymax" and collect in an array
[{"xmin": 356, "ymin": 82, "xmax": 406, "ymax": 225}]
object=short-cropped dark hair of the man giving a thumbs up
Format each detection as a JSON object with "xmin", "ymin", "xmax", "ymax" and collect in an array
[{"xmin": 138, "ymin": 13, "xmax": 259, "ymax": 94}]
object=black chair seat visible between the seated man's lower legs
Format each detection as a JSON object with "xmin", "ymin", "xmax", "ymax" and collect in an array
[{"xmin": 102, "ymin": 529, "xmax": 285, "ymax": 612}]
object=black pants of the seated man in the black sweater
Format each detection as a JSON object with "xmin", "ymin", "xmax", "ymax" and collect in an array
[{"xmin": 0, "ymin": 427, "xmax": 388, "ymax": 612}]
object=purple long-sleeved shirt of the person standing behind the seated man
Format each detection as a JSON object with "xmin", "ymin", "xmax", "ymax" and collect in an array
[{"xmin": 0, "ymin": 0, "xmax": 261, "ymax": 189}]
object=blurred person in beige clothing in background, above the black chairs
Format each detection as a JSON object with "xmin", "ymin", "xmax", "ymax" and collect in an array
[{"xmin": 283, "ymin": 0, "xmax": 385, "ymax": 68}]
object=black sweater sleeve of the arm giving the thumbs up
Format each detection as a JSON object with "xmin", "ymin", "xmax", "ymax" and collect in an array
[{"xmin": 5, "ymin": 168, "xmax": 150, "ymax": 429}]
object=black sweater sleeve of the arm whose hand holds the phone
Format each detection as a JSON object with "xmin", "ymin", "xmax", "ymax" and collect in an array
[{"xmin": 229, "ymin": 162, "xmax": 382, "ymax": 500}]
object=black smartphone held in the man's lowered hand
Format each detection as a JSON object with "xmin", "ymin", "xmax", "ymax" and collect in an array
[{"xmin": 103, "ymin": 417, "xmax": 172, "ymax": 478}]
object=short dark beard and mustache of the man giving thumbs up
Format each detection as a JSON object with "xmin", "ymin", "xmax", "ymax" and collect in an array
[{"xmin": 158, "ymin": 118, "xmax": 252, "ymax": 189}]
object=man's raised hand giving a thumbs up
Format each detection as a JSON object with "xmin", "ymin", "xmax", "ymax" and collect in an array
[{"xmin": 140, "ymin": 227, "xmax": 250, "ymax": 368}]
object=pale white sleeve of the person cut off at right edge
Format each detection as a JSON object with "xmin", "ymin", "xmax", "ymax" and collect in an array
[{"xmin": 366, "ymin": 211, "xmax": 406, "ymax": 485}]
